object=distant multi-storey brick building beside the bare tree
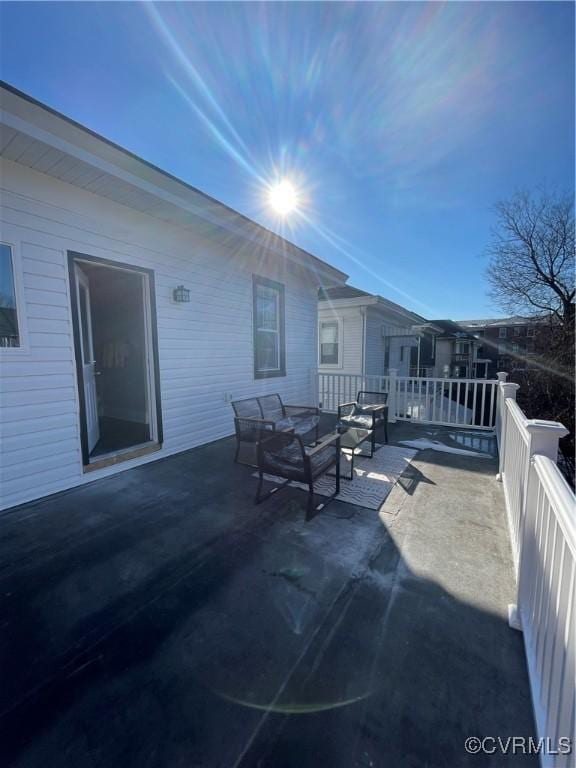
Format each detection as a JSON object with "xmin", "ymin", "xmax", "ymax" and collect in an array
[{"xmin": 458, "ymin": 317, "xmax": 545, "ymax": 379}]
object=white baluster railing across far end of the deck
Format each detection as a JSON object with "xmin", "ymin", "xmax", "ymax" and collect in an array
[{"xmin": 316, "ymin": 370, "xmax": 498, "ymax": 430}]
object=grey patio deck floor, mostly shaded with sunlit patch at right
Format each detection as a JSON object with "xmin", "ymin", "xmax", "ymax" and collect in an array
[{"xmin": 0, "ymin": 419, "xmax": 537, "ymax": 768}]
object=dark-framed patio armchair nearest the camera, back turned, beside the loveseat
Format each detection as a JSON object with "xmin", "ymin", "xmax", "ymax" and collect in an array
[{"xmin": 254, "ymin": 432, "xmax": 340, "ymax": 519}]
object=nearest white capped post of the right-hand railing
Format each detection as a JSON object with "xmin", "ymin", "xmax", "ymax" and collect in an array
[{"xmin": 508, "ymin": 419, "xmax": 568, "ymax": 630}]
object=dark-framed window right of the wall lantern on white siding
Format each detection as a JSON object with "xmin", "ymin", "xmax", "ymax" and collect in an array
[{"xmin": 253, "ymin": 276, "xmax": 286, "ymax": 379}]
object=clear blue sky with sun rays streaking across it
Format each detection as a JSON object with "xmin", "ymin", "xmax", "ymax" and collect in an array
[{"xmin": 0, "ymin": 2, "xmax": 575, "ymax": 319}]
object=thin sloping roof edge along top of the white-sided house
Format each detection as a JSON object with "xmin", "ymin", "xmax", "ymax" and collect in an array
[{"xmin": 0, "ymin": 79, "xmax": 348, "ymax": 283}]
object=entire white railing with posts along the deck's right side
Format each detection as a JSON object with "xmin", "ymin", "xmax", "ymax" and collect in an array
[{"xmin": 496, "ymin": 374, "xmax": 576, "ymax": 768}]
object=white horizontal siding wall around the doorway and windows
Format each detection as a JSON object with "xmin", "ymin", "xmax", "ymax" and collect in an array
[{"xmin": 0, "ymin": 161, "xmax": 318, "ymax": 508}]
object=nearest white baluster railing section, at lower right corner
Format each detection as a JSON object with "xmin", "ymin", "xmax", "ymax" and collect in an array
[{"xmin": 518, "ymin": 456, "xmax": 576, "ymax": 768}]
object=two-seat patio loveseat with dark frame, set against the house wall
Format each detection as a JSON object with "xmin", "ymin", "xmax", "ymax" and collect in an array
[{"xmin": 232, "ymin": 395, "xmax": 320, "ymax": 467}]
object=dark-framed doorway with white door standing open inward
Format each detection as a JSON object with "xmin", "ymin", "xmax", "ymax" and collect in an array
[{"xmin": 70, "ymin": 254, "xmax": 161, "ymax": 468}]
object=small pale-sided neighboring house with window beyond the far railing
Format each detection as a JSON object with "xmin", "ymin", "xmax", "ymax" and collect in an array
[{"xmin": 318, "ymin": 285, "xmax": 426, "ymax": 376}]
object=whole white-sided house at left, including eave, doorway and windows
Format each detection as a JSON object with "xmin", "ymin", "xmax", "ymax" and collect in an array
[{"xmin": 0, "ymin": 87, "xmax": 346, "ymax": 507}]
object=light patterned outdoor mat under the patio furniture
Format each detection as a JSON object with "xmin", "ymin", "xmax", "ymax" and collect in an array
[{"xmin": 254, "ymin": 445, "xmax": 418, "ymax": 510}]
